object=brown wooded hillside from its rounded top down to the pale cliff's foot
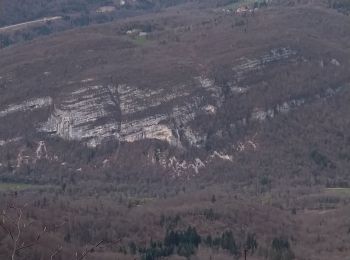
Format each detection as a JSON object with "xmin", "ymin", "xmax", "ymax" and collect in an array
[{"xmin": 1, "ymin": 2, "xmax": 349, "ymax": 177}]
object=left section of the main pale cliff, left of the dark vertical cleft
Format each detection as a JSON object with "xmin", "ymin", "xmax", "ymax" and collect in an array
[{"xmin": 39, "ymin": 85, "xmax": 120, "ymax": 146}]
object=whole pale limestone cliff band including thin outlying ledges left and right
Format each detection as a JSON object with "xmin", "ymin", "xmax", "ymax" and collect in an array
[{"xmin": 0, "ymin": 47, "xmax": 339, "ymax": 156}]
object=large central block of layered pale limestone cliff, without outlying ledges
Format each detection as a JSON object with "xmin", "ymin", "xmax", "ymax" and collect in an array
[{"xmin": 39, "ymin": 77, "xmax": 220, "ymax": 147}]
